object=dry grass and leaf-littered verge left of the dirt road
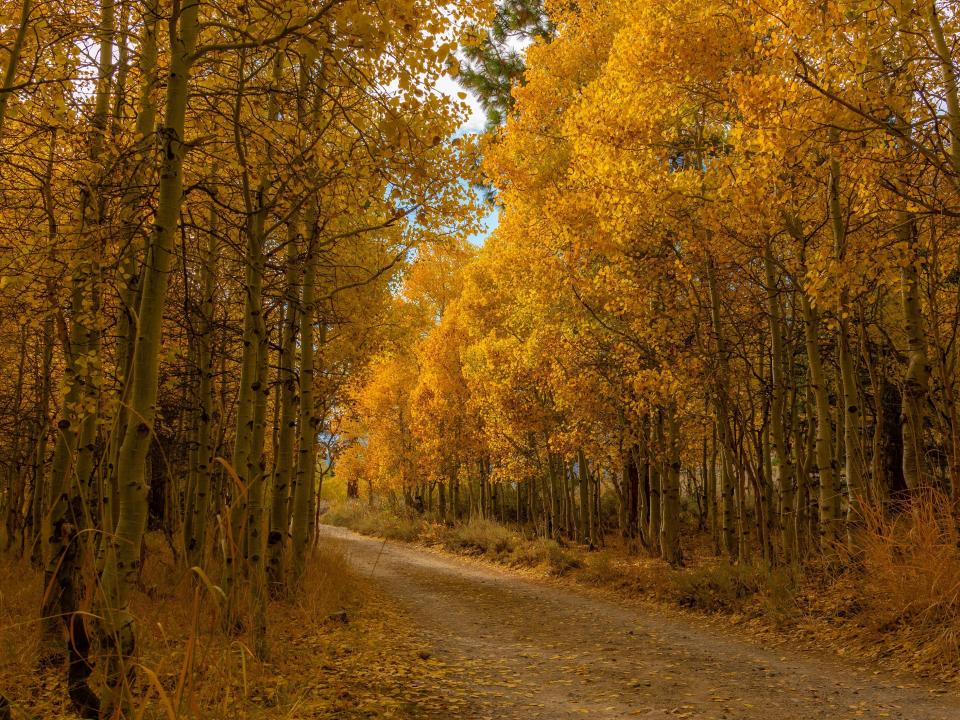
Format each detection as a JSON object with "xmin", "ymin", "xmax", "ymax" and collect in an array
[{"xmin": 0, "ymin": 536, "xmax": 468, "ymax": 720}]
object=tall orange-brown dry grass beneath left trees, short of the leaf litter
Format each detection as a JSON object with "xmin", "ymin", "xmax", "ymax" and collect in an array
[{"xmin": 0, "ymin": 536, "xmax": 363, "ymax": 720}]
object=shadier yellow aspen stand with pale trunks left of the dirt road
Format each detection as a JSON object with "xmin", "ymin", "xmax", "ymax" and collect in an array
[{"xmin": 0, "ymin": 0, "xmax": 478, "ymax": 717}]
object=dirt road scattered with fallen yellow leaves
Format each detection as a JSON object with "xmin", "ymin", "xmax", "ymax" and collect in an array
[{"xmin": 322, "ymin": 527, "xmax": 960, "ymax": 720}]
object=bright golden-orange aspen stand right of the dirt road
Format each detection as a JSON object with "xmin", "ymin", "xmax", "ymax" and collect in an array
[{"xmin": 340, "ymin": 0, "xmax": 960, "ymax": 565}]
